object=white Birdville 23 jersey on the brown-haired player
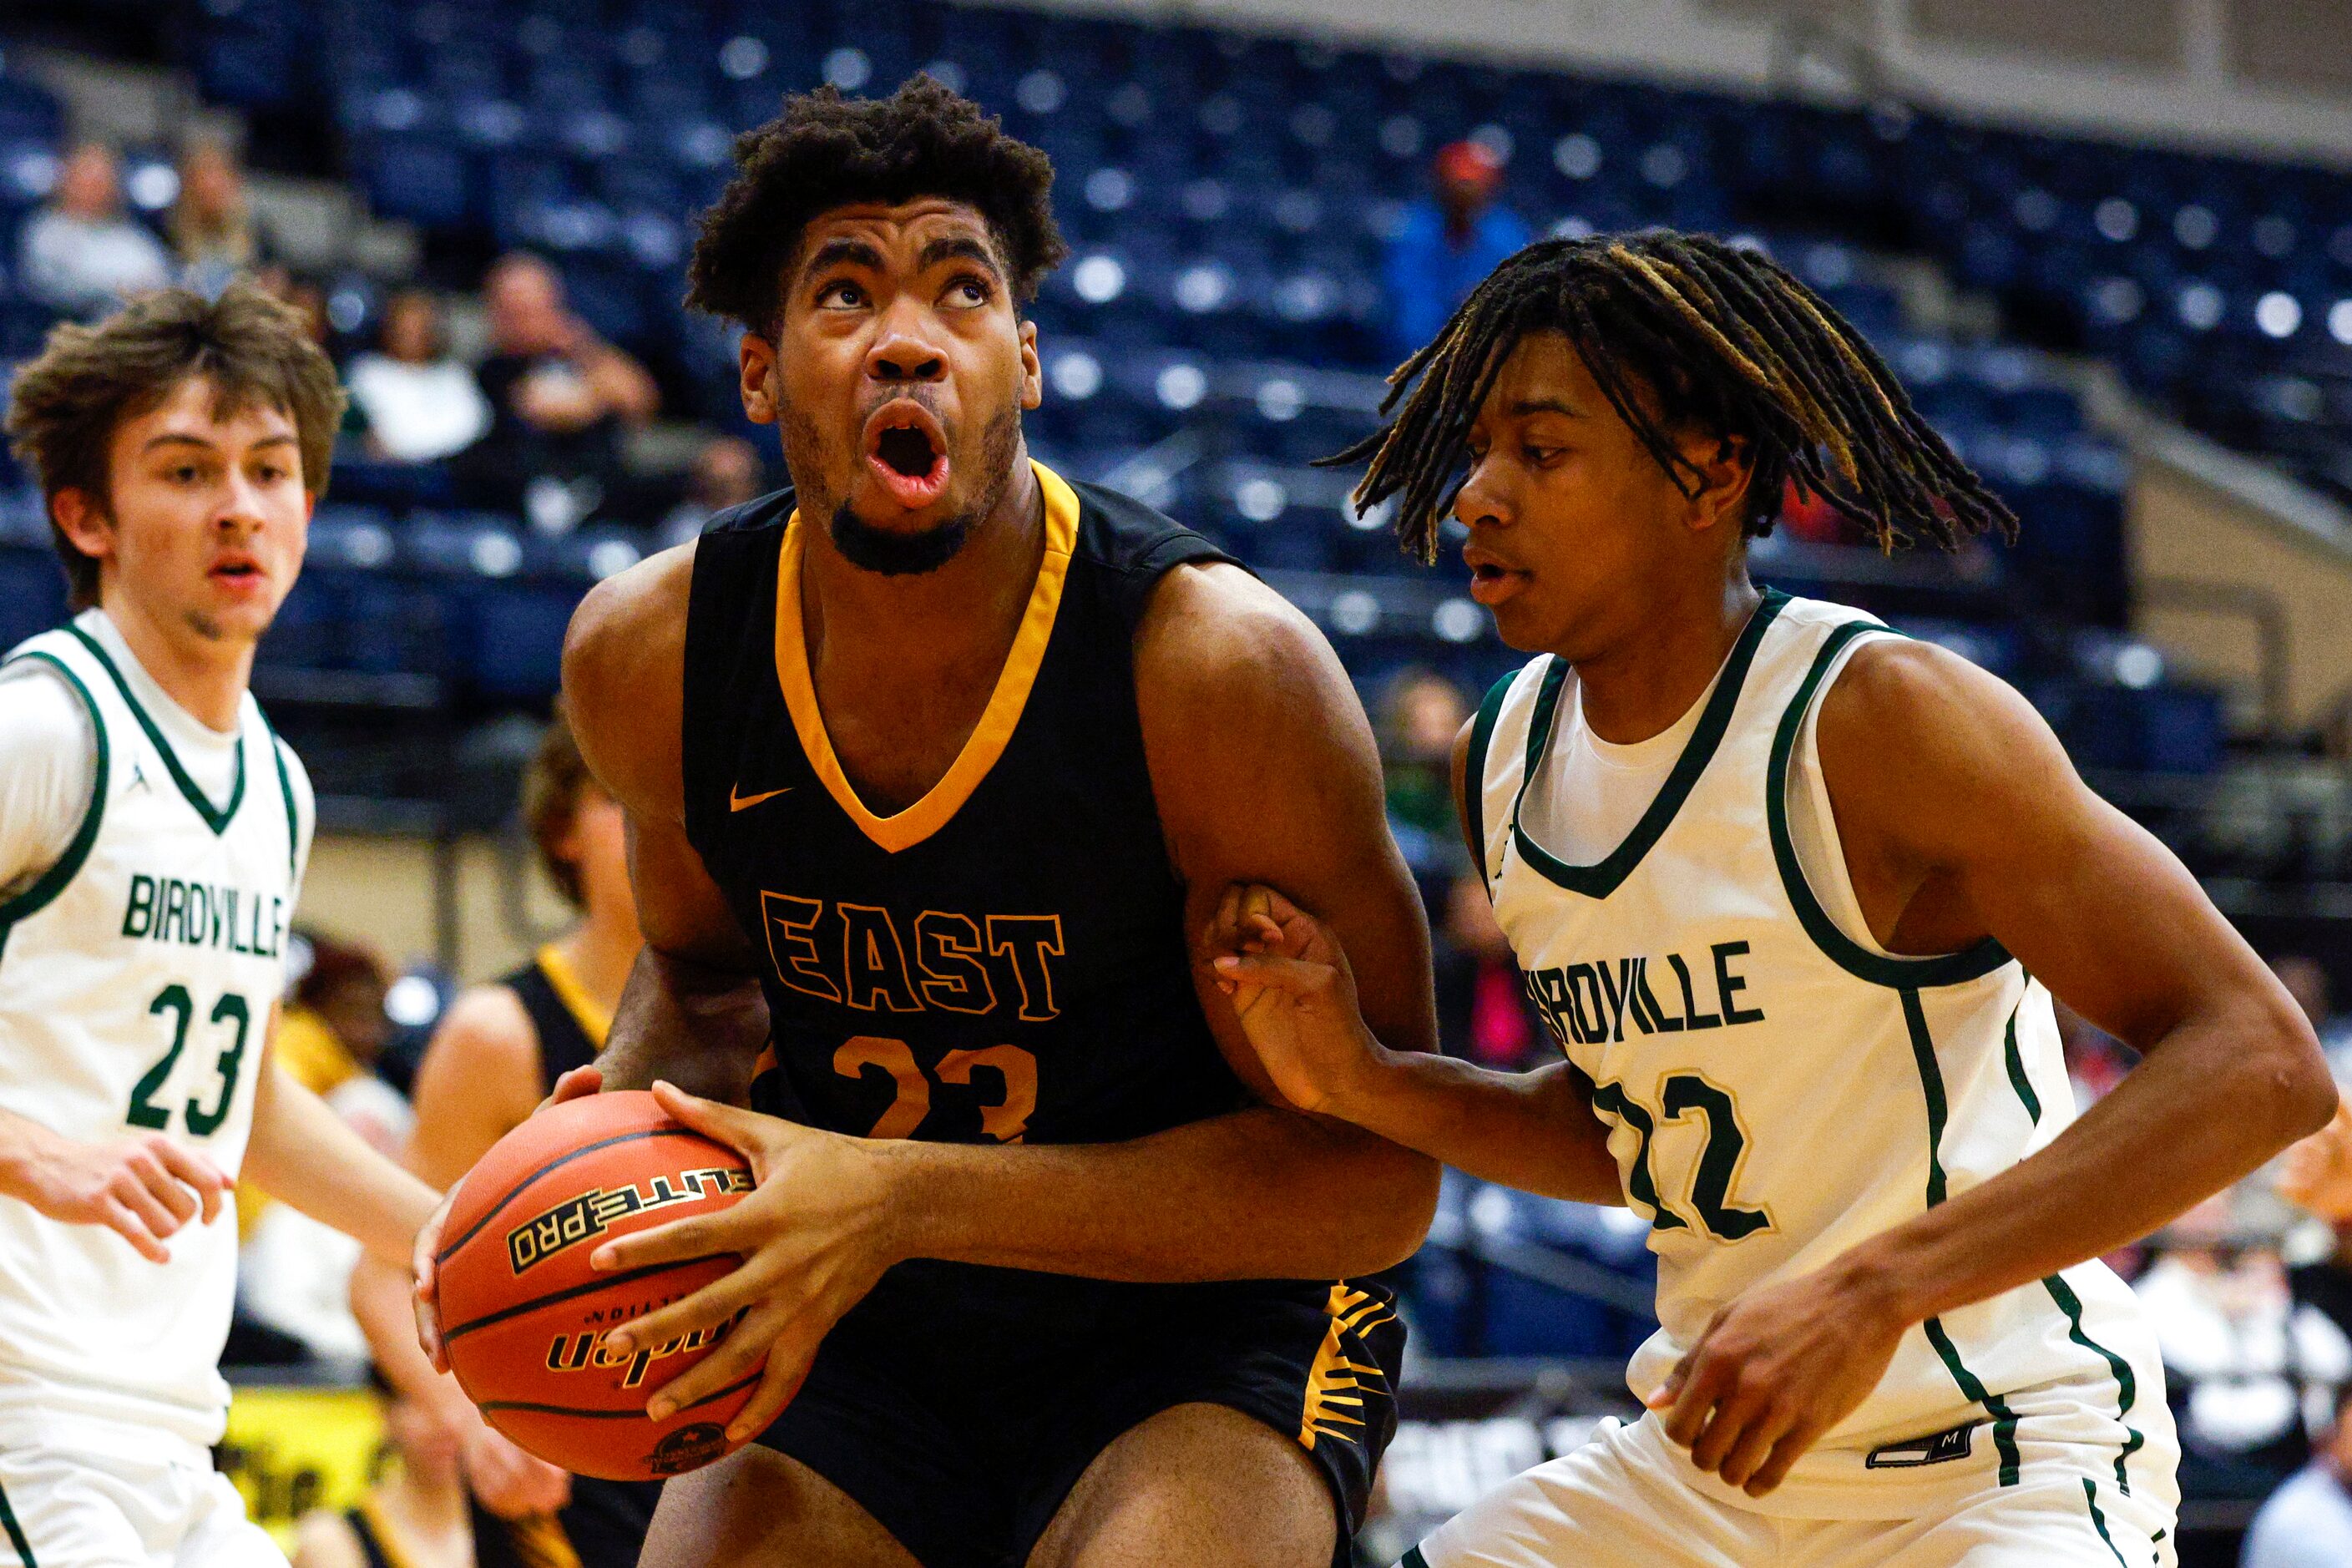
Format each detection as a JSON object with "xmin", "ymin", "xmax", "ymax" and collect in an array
[{"xmin": 0, "ymin": 625, "xmax": 311, "ymax": 1444}]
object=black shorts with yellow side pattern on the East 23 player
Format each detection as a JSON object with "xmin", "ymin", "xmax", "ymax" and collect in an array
[{"xmin": 760, "ymin": 1260, "xmax": 1404, "ymax": 1568}]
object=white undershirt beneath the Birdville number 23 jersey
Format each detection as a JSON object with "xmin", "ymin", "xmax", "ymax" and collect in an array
[{"xmin": 0, "ymin": 609, "xmax": 238, "ymax": 898}]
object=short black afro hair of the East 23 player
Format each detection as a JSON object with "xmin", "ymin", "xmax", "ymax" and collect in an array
[{"xmin": 687, "ymin": 75, "xmax": 1068, "ymax": 334}]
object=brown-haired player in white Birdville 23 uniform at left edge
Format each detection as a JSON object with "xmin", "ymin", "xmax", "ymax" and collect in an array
[{"xmin": 0, "ymin": 282, "xmax": 432, "ymax": 1568}]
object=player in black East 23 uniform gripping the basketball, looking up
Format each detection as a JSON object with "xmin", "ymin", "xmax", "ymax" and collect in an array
[{"xmin": 418, "ymin": 80, "xmax": 1437, "ymax": 1568}]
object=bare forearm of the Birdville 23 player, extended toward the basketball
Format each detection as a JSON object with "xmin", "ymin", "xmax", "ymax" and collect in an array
[{"xmin": 245, "ymin": 1060, "xmax": 438, "ymax": 1265}]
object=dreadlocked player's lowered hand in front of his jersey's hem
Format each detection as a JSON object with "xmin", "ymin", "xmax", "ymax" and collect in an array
[{"xmin": 1649, "ymin": 1265, "xmax": 1908, "ymax": 1498}]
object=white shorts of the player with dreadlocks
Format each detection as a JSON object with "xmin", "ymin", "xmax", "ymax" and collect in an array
[{"xmin": 1399, "ymin": 1418, "xmax": 2178, "ymax": 1568}]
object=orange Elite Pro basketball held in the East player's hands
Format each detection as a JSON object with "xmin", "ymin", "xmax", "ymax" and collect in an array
[{"xmin": 440, "ymin": 1090, "xmax": 757, "ymax": 1481}]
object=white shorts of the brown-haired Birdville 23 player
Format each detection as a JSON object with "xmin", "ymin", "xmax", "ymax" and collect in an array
[{"xmin": 0, "ymin": 1446, "xmax": 287, "ymax": 1568}]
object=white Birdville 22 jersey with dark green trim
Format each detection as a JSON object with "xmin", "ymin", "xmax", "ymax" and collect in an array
[{"xmin": 1470, "ymin": 593, "xmax": 2173, "ymax": 1516}]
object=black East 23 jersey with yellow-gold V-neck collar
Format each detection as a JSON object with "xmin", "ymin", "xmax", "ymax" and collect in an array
[{"xmin": 685, "ymin": 465, "xmax": 1244, "ymax": 1142}]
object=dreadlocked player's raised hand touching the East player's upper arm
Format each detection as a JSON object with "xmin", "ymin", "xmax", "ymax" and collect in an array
[{"xmin": 1201, "ymin": 886, "xmax": 1381, "ymax": 1115}]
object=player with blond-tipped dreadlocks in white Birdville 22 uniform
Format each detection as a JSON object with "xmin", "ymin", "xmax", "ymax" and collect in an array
[{"xmin": 1211, "ymin": 233, "xmax": 2335, "ymax": 1568}]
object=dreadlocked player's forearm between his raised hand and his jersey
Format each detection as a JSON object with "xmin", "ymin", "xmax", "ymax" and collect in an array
[{"xmin": 1324, "ymin": 1049, "xmax": 1626, "ymax": 1204}]
